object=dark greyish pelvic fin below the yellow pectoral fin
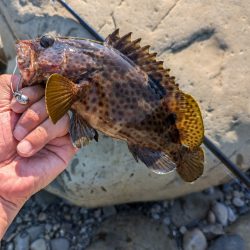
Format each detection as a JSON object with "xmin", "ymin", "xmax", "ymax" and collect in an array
[{"xmin": 70, "ymin": 110, "xmax": 98, "ymax": 148}]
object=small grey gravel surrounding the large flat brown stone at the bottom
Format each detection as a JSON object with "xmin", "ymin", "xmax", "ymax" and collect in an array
[{"xmin": 1, "ymin": 171, "xmax": 250, "ymax": 250}]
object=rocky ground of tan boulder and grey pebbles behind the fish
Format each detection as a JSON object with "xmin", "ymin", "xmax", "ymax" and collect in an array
[{"xmin": 0, "ymin": 0, "xmax": 250, "ymax": 250}]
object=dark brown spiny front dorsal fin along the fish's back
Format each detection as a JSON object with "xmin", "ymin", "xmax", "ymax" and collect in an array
[{"xmin": 105, "ymin": 29, "xmax": 179, "ymax": 91}]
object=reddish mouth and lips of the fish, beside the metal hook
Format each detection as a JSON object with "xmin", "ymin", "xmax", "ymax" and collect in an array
[{"xmin": 16, "ymin": 40, "xmax": 36, "ymax": 85}]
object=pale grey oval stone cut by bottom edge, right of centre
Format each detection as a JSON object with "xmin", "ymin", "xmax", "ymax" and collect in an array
[{"xmin": 183, "ymin": 228, "xmax": 207, "ymax": 250}]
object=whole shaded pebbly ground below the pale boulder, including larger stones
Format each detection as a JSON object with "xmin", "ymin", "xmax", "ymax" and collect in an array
[{"xmin": 1, "ymin": 172, "xmax": 250, "ymax": 250}]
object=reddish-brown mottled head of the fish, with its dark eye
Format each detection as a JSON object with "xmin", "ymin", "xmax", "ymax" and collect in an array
[{"xmin": 16, "ymin": 35, "xmax": 102, "ymax": 86}]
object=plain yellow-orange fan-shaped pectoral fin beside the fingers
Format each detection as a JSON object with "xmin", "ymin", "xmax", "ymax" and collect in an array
[{"xmin": 45, "ymin": 74, "xmax": 79, "ymax": 124}]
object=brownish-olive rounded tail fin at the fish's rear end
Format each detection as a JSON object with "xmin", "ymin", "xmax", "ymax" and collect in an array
[{"xmin": 176, "ymin": 147, "xmax": 204, "ymax": 182}]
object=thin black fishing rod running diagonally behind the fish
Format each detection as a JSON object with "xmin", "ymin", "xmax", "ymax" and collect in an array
[{"xmin": 57, "ymin": 0, "xmax": 250, "ymax": 188}]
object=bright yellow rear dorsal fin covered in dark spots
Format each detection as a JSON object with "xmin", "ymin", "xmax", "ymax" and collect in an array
[{"xmin": 167, "ymin": 91, "xmax": 204, "ymax": 149}]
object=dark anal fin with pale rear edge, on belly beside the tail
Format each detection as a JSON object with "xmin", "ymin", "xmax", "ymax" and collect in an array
[{"xmin": 128, "ymin": 144, "xmax": 176, "ymax": 174}]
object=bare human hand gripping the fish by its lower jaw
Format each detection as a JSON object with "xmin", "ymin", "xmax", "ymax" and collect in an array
[{"xmin": 0, "ymin": 75, "xmax": 76, "ymax": 238}]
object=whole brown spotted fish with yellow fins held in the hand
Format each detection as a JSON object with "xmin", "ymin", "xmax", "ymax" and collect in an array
[{"xmin": 16, "ymin": 29, "xmax": 204, "ymax": 182}]
